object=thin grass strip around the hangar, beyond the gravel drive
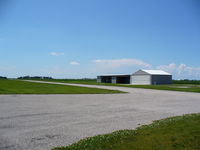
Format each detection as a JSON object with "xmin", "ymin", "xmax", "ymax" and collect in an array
[{"xmin": 28, "ymin": 79, "xmax": 200, "ymax": 93}]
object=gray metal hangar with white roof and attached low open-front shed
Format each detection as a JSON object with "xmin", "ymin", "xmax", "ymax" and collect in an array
[{"xmin": 97, "ymin": 70, "xmax": 172, "ymax": 85}]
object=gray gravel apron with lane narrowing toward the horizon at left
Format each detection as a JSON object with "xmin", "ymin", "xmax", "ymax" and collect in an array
[{"xmin": 0, "ymin": 83, "xmax": 200, "ymax": 150}]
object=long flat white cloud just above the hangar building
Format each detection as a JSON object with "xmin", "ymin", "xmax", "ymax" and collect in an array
[{"xmin": 93, "ymin": 58, "xmax": 151, "ymax": 69}]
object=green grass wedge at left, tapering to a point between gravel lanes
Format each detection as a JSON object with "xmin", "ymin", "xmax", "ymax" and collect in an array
[{"xmin": 0, "ymin": 79, "xmax": 124, "ymax": 94}]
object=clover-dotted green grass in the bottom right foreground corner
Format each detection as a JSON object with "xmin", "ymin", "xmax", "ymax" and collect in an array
[{"xmin": 52, "ymin": 114, "xmax": 200, "ymax": 150}]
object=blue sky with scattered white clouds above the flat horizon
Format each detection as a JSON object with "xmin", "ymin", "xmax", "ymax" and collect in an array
[{"xmin": 0, "ymin": 0, "xmax": 200, "ymax": 80}]
